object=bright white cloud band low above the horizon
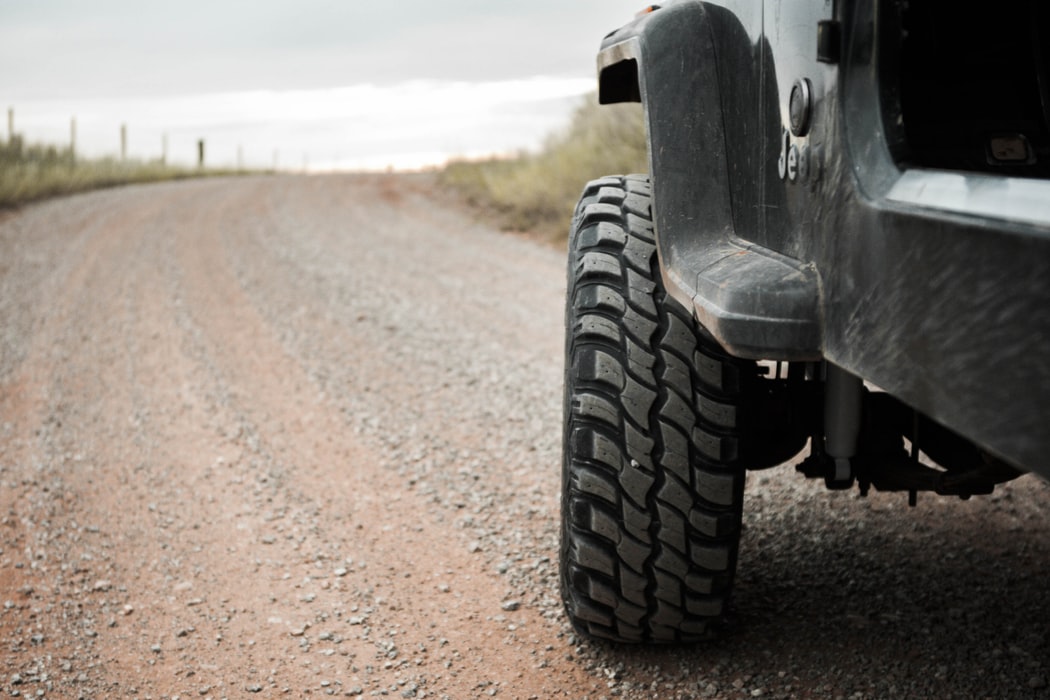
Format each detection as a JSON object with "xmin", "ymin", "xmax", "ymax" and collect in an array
[{"xmin": 17, "ymin": 78, "xmax": 591, "ymax": 169}]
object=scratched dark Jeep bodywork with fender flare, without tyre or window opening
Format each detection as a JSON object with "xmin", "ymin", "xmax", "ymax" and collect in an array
[{"xmin": 600, "ymin": 0, "xmax": 1050, "ymax": 476}]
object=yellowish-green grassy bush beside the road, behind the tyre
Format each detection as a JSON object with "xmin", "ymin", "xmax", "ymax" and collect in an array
[{"xmin": 441, "ymin": 94, "xmax": 648, "ymax": 241}]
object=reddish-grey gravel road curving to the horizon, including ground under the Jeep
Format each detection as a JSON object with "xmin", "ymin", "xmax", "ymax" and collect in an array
[{"xmin": 0, "ymin": 175, "xmax": 1050, "ymax": 700}]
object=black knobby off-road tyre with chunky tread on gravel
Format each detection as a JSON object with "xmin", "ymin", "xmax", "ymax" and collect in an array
[{"xmin": 561, "ymin": 175, "xmax": 758, "ymax": 642}]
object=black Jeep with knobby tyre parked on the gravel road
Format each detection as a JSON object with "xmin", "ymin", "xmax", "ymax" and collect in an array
[{"xmin": 561, "ymin": 0, "xmax": 1050, "ymax": 642}]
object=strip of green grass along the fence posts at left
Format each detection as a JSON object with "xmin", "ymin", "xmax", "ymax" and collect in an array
[{"xmin": 0, "ymin": 135, "xmax": 245, "ymax": 209}]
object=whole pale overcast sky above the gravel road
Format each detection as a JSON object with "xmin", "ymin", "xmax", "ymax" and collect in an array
[{"xmin": 0, "ymin": 0, "xmax": 644, "ymax": 165}]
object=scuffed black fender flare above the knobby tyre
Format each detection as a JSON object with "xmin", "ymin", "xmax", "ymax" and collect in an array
[{"xmin": 599, "ymin": 0, "xmax": 821, "ymax": 367}]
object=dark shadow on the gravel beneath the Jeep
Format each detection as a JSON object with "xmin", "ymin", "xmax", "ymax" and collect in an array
[{"xmin": 600, "ymin": 473, "xmax": 1050, "ymax": 698}]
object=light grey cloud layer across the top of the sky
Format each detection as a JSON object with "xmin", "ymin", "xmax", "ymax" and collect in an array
[{"xmin": 0, "ymin": 0, "xmax": 637, "ymax": 100}]
